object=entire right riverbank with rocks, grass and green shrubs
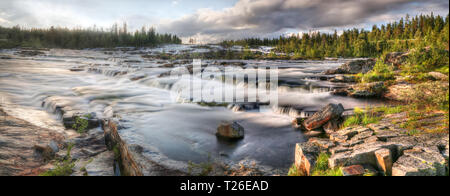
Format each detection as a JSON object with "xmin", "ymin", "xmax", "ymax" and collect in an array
[{"xmin": 290, "ymin": 52, "xmax": 449, "ymax": 176}]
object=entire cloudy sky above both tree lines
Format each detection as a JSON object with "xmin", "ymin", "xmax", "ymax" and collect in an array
[{"xmin": 0, "ymin": 0, "xmax": 449, "ymax": 42}]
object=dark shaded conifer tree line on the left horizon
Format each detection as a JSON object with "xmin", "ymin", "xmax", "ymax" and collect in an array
[{"xmin": 0, "ymin": 23, "xmax": 181, "ymax": 49}]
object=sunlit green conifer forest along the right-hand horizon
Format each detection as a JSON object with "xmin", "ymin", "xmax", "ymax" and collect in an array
[{"xmin": 221, "ymin": 14, "xmax": 449, "ymax": 58}]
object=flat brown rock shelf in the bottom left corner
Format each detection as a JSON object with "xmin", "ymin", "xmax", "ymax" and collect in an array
[{"xmin": 0, "ymin": 109, "xmax": 64, "ymax": 176}]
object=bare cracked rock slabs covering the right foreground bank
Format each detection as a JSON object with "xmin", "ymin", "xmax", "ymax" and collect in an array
[{"xmin": 295, "ymin": 107, "xmax": 449, "ymax": 176}]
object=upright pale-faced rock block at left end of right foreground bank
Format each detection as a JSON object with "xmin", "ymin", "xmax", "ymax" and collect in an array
[{"xmin": 295, "ymin": 143, "xmax": 320, "ymax": 176}]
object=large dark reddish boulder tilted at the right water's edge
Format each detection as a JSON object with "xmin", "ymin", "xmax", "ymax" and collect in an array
[{"xmin": 303, "ymin": 104, "xmax": 344, "ymax": 131}]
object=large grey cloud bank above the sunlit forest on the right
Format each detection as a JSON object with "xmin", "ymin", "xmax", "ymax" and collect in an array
[{"xmin": 158, "ymin": 0, "xmax": 449, "ymax": 42}]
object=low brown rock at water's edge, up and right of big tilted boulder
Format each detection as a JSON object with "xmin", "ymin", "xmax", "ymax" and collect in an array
[{"xmin": 350, "ymin": 82, "xmax": 387, "ymax": 98}]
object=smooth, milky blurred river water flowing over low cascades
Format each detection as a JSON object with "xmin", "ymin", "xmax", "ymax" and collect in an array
[{"xmin": 0, "ymin": 45, "xmax": 386, "ymax": 175}]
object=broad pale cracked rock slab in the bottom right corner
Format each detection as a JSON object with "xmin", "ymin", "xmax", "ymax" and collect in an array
[{"xmin": 392, "ymin": 148, "xmax": 446, "ymax": 176}]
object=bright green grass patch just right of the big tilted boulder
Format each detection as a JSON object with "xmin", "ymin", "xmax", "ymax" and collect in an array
[{"xmin": 342, "ymin": 108, "xmax": 381, "ymax": 128}]
